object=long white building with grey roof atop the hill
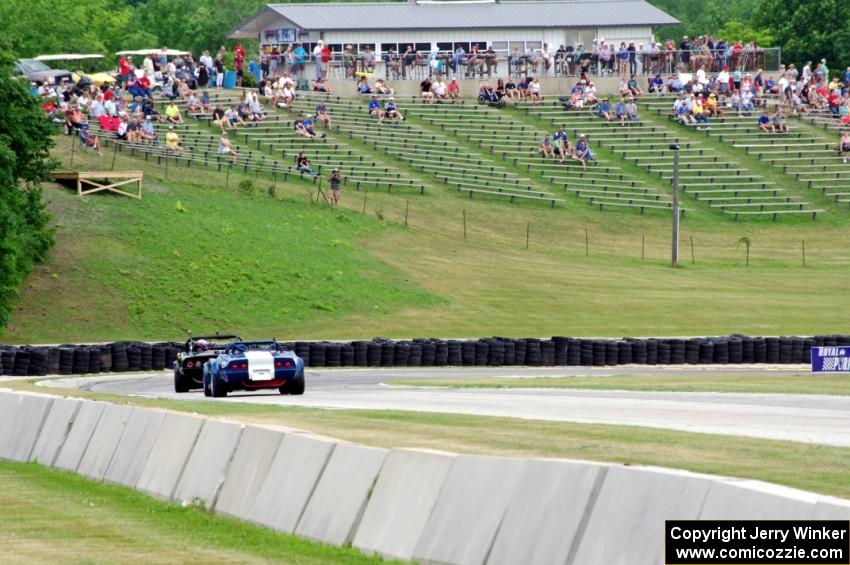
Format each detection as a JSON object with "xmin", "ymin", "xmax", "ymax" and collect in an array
[{"xmin": 228, "ymin": 0, "xmax": 679, "ymax": 71}]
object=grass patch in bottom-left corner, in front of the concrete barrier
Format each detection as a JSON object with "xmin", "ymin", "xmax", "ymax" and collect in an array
[{"xmin": 0, "ymin": 461, "xmax": 390, "ymax": 565}]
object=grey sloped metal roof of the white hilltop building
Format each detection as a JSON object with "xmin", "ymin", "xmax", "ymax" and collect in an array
[{"xmin": 228, "ymin": 0, "xmax": 679, "ymax": 38}]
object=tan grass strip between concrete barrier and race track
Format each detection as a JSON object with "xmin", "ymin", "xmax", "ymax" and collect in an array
[{"xmin": 8, "ymin": 381, "xmax": 850, "ymax": 498}]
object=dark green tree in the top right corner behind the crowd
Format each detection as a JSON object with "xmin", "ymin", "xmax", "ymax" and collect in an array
[{"xmin": 755, "ymin": 0, "xmax": 850, "ymax": 70}]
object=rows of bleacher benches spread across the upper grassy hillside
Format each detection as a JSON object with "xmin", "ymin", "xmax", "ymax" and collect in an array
[{"xmin": 69, "ymin": 88, "xmax": 850, "ymax": 220}]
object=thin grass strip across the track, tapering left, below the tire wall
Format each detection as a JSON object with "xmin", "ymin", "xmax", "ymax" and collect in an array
[{"xmin": 388, "ymin": 374, "xmax": 850, "ymax": 396}]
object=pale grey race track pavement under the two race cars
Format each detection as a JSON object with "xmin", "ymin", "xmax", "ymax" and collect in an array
[{"xmin": 43, "ymin": 367, "xmax": 850, "ymax": 446}]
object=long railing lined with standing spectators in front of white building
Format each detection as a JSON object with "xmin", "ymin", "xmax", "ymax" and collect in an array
[{"xmin": 260, "ymin": 47, "xmax": 782, "ymax": 80}]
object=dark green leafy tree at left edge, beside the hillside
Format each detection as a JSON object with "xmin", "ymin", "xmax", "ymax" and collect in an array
[{"xmin": 0, "ymin": 39, "xmax": 53, "ymax": 326}]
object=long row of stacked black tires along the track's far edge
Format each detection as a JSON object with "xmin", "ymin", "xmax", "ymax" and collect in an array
[{"xmin": 0, "ymin": 335, "xmax": 850, "ymax": 376}]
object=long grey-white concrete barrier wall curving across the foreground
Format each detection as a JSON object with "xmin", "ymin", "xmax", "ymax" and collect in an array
[{"xmin": 0, "ymin": 391, "xmax": 850, "ymax": 565}]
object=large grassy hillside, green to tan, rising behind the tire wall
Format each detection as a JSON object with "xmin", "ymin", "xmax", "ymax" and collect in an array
[{"xmin": 0, "ymin": 94, "xmax": 850, "ymax": 343}]
